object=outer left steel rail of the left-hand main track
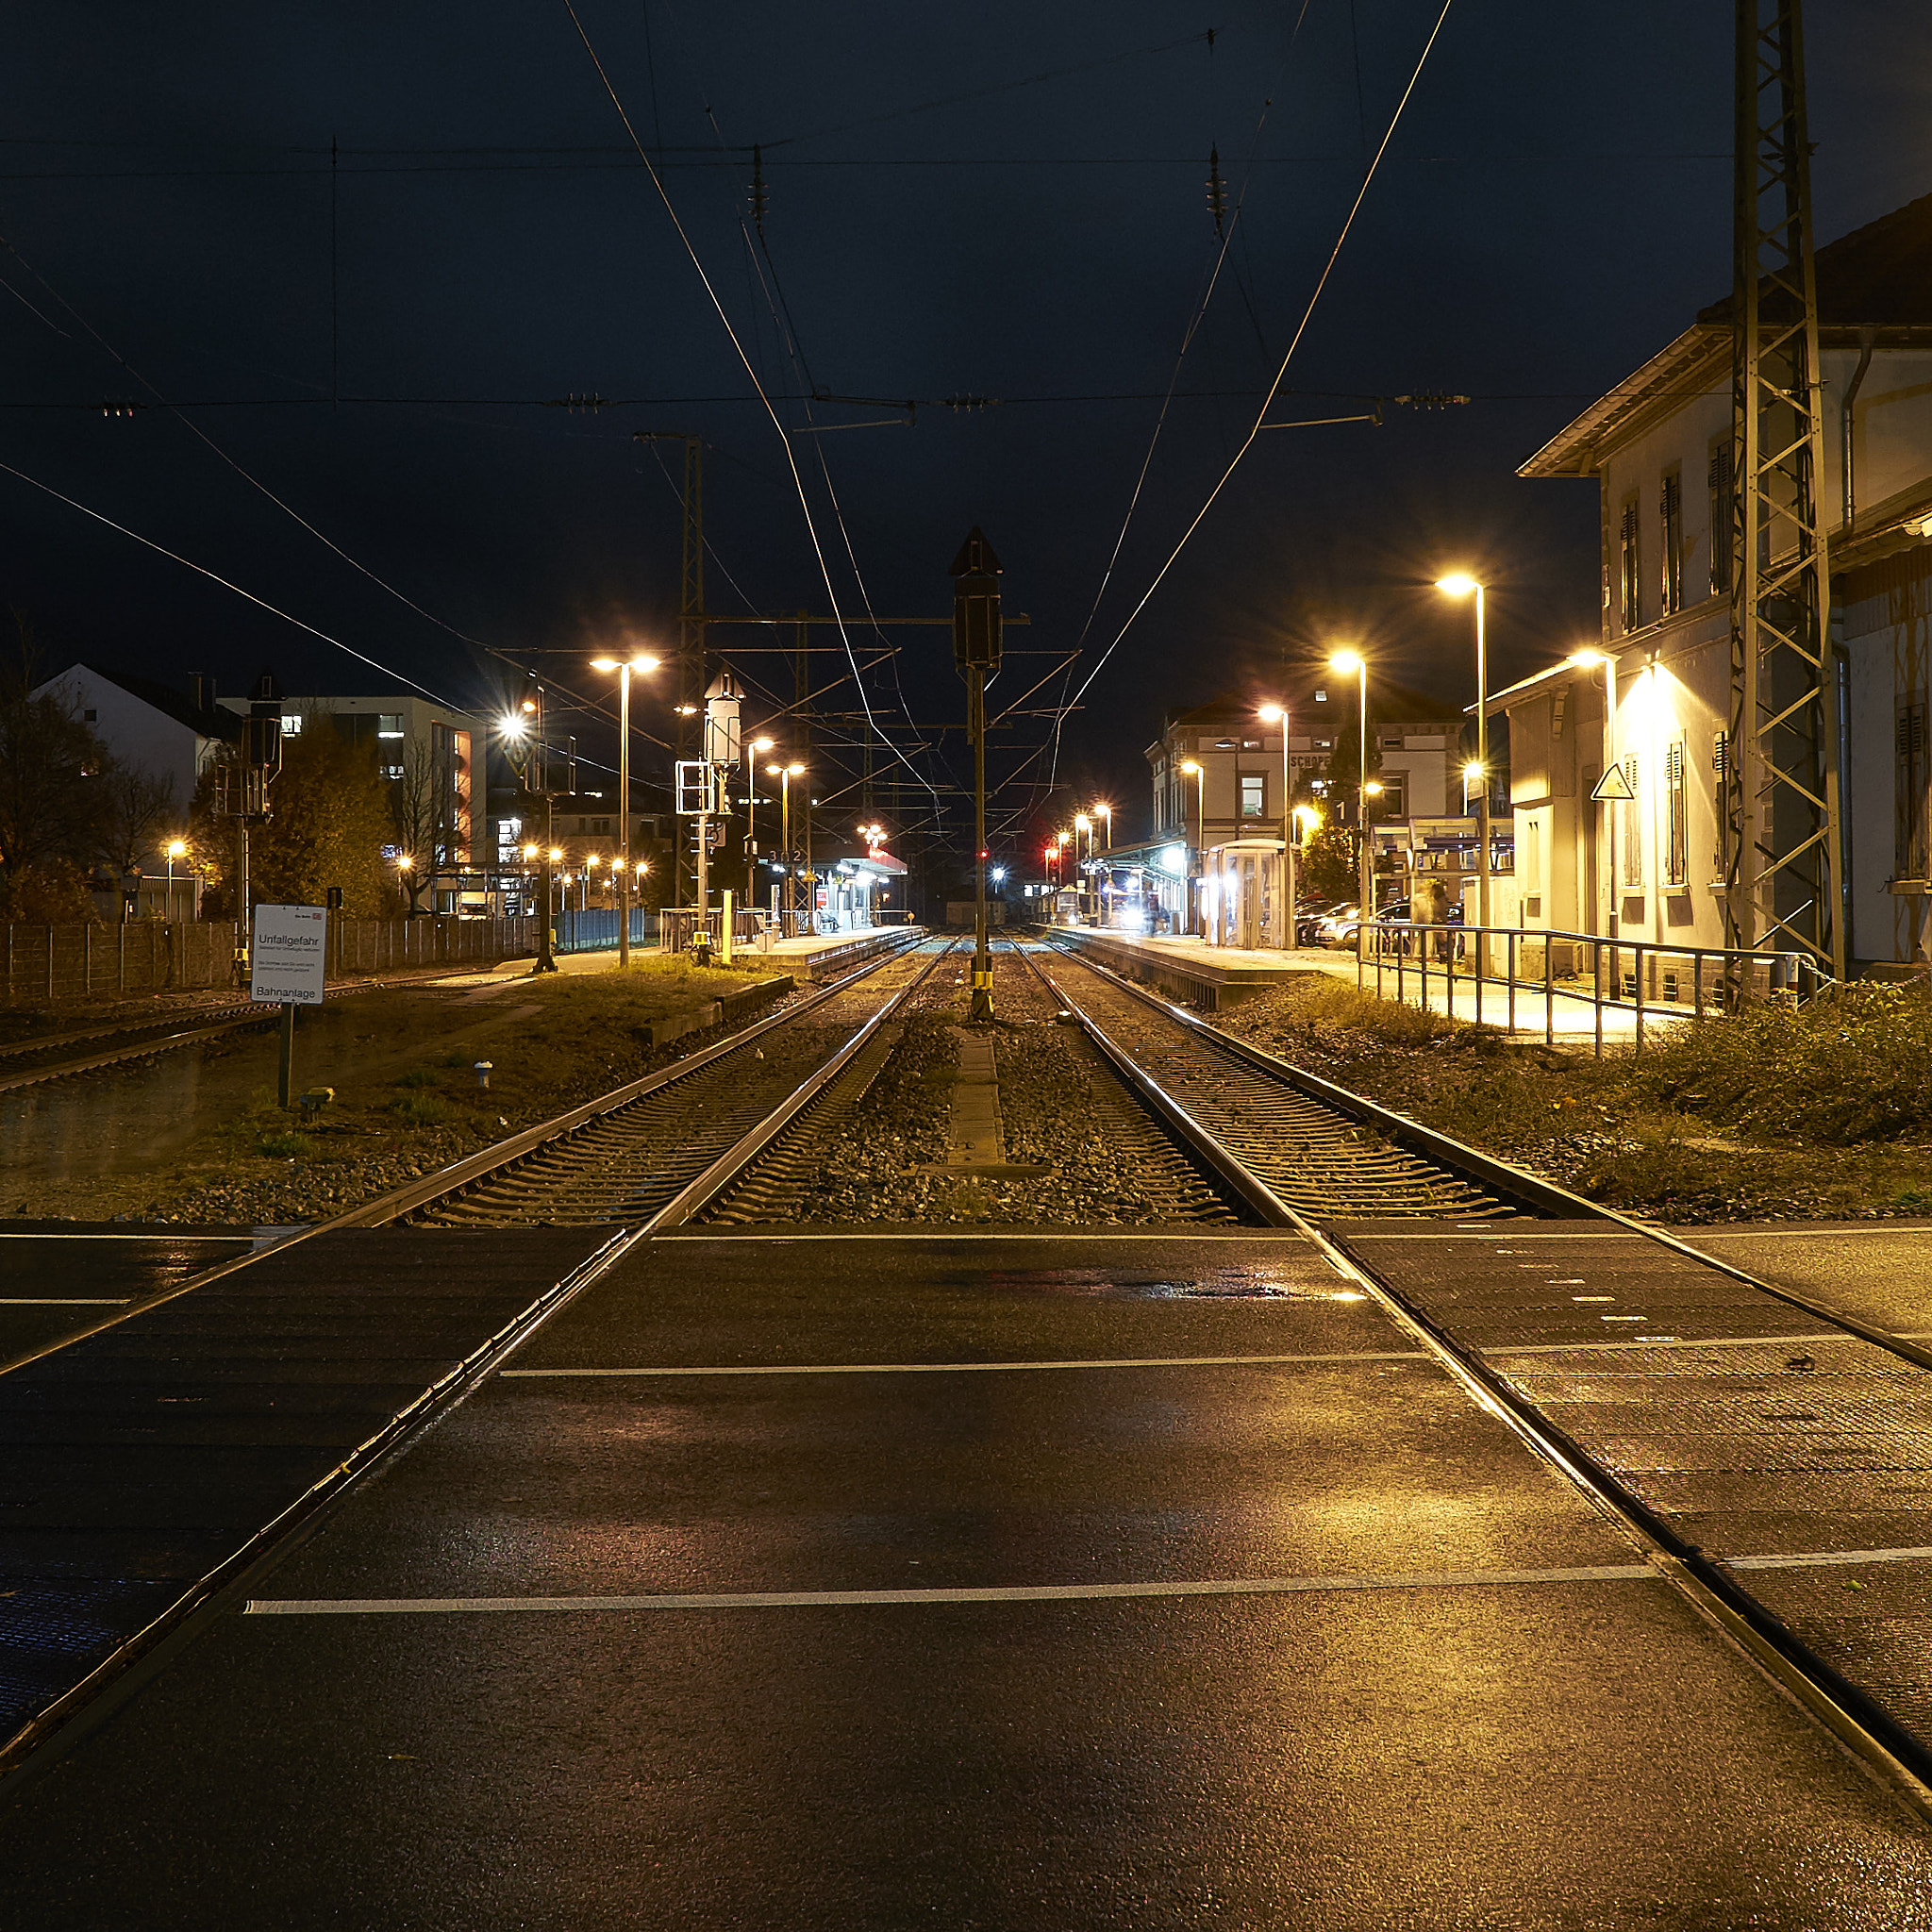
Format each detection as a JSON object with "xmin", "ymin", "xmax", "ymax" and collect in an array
[{"xmin": 0, "ymin": 927, "xmax": 924, "ymax": 1375}]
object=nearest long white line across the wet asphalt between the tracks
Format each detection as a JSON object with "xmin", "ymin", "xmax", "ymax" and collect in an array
[{"xmin": 243, "ymin": 1563, "xmax": 1663, "ymax": 1617}]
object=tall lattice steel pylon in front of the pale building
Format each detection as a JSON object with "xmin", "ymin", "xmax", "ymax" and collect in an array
[{"xmin": 1724, "ymin": 0, "xmax": 1845, "ymax": 977}]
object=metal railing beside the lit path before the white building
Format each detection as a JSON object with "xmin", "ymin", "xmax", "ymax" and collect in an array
[{"xmin": 1357, "ymin": 922, "xmax": 1834, "ymax": 1058}]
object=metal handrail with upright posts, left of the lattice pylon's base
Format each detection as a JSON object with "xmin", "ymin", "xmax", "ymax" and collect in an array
[{"xmin": 1355, "ymin": 920, "xmax": 1838, "ymax": 1058}]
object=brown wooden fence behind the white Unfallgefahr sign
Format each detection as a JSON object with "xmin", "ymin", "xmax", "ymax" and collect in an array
[{"xmin": 0, "ymin": 918, "xmax": 535, "ymax": 1007}]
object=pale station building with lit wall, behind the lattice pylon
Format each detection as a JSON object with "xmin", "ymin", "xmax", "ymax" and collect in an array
[{"xmin": 1491, "ymin": 197, "xmax": 1932, "ymax": 966}]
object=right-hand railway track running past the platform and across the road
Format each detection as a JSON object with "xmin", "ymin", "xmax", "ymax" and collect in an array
[{"xmin": 1041, "ymin": 931, "xmax": 1932, "ymax": 1824}]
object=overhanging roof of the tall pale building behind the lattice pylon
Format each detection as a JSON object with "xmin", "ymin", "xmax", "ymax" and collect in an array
[{"xmin": 1517, "ymin": 195, "xmax": 1932, "ymax": 477}]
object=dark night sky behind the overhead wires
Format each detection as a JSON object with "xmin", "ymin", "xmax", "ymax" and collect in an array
[{"xmin": 0, "ymin": 0, "xmax": 1932, "ymax": 858}]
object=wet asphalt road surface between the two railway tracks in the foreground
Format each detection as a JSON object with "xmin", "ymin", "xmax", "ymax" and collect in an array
[{"xmin": 0, "ymin": 1235, "xmax": 1932, "ymax": 1932}]
